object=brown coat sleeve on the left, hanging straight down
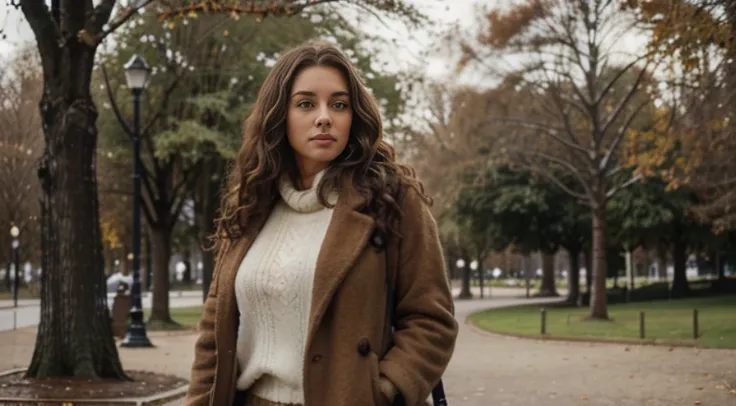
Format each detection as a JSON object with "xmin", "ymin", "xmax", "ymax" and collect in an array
[{"xmin": 184, "ymin": 249, "xmax": 222, "ymax": 406}]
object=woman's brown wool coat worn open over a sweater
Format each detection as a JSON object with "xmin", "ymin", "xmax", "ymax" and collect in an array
[{"xmin": 186, "ymin": 182, "xmax": 457, "ymax": 406}]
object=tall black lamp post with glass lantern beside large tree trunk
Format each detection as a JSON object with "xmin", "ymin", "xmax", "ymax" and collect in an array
[{"xmin": 120, "ymin": 55, "xmax": 153, "ymax": 347}]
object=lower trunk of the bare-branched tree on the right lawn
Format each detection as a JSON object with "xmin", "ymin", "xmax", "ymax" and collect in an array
[{"xmin": 588, "ymin": 208, "xmax": 608, "ymax": 320}]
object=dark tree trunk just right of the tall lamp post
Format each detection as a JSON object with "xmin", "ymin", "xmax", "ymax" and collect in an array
[{"xmin": 148, "ymin": 228, "xmax": 176, "ymax": 328}]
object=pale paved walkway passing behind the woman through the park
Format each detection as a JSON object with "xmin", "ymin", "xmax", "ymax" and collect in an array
[{"xmin": 0, "ymin": 291, "xmax": 736, "ymax": 406}]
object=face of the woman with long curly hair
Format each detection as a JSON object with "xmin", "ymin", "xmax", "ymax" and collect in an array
[{"xmin": 286, "ymin": 66, "xmax": 353, "ymax": 177}]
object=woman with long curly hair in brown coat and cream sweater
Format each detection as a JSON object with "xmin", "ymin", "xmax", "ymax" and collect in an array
[{"xmin": 186, "ymin": 44, "xmax": 457, "ymax": 406}]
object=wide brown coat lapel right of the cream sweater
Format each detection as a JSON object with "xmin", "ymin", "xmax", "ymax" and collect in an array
[{"xmin": 307, "ymin": 182, "xmax": 375, "ymax": 348}]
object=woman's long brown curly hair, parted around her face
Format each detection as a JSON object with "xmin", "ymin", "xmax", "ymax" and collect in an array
[{"xmin": 213, "ymin": 43, "xmax": 431, "ymax": 249}]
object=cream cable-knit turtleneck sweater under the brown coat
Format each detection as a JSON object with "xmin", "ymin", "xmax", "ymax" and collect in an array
[{"xmin": 235, "ymin": 171, "xmax": 336, "ymax": 404}]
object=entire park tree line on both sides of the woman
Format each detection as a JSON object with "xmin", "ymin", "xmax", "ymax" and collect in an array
[{"xmin": 0, "ymin": 0, "xmax": 736, "ymax": 377}]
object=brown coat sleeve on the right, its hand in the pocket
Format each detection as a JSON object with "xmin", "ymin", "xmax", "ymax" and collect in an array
[{"xmin": 379, "ymin": 188, "xmax": 458, "ymax": 405}]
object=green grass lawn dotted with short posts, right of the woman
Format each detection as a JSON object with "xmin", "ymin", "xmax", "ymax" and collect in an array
[{"xmin": 470, "ymin": 295, "xmax": 736, "ymax": 349}]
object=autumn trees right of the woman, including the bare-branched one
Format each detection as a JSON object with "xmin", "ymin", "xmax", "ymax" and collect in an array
[{"xmin": 414, "ymin": 0, "xmax": 736, "ymax": 319}]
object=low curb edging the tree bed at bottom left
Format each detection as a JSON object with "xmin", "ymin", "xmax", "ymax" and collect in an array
[{"xmin": 0, "ymin": 368, "xmax": 189, "ymax": 406}]
